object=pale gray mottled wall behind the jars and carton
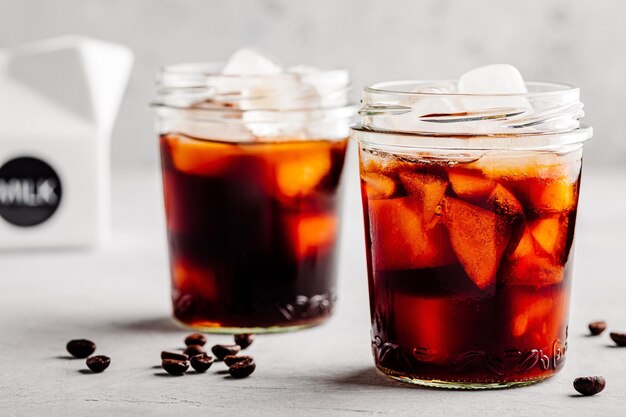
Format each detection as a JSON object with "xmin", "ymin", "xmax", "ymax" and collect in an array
[{"xmin": 0, "ymin": 0, "xmax": 626, "ymax": 165}]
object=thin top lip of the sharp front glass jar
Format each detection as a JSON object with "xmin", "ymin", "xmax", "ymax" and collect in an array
[{"xmin": 363, "ymin": 79, "xmax": 580, "ymax": 98}]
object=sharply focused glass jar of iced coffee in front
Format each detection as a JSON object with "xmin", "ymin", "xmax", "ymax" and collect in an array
[{"xmin": 352, "ymin": 82, "xmax": 592, "ymax": 388}]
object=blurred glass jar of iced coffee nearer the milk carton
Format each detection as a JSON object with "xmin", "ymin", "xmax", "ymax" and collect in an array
[{"xmin": 153, "ymin": 64, "xmax": 354, "ymax": 333}]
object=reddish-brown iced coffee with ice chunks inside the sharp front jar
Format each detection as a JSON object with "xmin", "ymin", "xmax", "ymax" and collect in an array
[{"xmin": 361, "ymin": 149, "xmax": 580, "ymax": 384}]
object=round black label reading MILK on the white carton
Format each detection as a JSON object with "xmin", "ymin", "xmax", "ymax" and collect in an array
[{"xmin": 0, "ymin": 157, "xmax": 61, "ymax": 226}]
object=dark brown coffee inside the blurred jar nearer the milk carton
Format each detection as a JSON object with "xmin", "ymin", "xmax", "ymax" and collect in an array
[{"xmin": 161, "ymin": 134, "xmax": 346, "ymax": 329}]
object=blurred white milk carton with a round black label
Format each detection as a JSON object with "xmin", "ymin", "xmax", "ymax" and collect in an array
[{"xmin": 0, "ymin": 36, "xmax": 133, "ymax": 249}]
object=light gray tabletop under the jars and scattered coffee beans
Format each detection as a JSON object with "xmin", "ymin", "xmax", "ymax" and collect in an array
[{"xmin": 0, "ymin": 169, "xmax": 626, "ymax": 416}]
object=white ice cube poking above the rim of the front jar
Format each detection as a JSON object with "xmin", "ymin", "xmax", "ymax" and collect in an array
[{"xmin": 457, "ymin": 64, "xmax": 528, "ymax": 94}]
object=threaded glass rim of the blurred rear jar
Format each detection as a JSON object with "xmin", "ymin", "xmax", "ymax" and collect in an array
[{"xmin": 152, "ymin": 62, "xmax": 351, "ymax": 114}]
